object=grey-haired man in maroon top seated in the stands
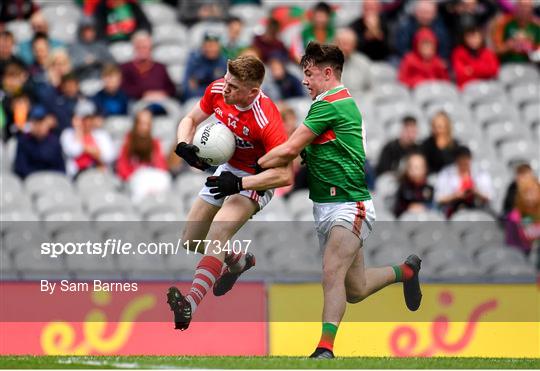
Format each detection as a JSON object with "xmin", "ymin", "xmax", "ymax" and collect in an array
[{"xmin": 120, "ymin": 31, "xmax": 175, "ymax": 100}]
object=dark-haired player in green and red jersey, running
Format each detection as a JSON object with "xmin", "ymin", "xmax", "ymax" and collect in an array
[{"xmin": 259, "ymin": 42, "xmax": 422, "ymax": 358}]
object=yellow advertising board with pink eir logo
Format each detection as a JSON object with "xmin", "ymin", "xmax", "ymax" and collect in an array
[{"xmin": 269, "ymin": 284, "xmax": 540, "ymax": 358}]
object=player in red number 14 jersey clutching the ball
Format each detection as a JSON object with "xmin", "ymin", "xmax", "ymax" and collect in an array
[{"xmin": 167, "ymin": 56, "xmax": 292, "ymax": 330}]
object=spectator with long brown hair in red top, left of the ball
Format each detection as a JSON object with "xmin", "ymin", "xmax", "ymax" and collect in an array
[{"xmin": 116, "ymin": 110, "xmax": 167, "ymax": 180}]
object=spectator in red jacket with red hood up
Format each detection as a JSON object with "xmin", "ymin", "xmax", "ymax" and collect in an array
[{"xmin": 399, "ymin": 27, "xmax": 448, "ymax": 88}]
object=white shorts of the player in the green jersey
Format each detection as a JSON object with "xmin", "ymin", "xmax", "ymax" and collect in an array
[{"xmin": 313, "ymin": 200, "xmax": 377, "ymax": 249}]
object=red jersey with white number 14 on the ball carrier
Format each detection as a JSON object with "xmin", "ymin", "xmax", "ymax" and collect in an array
[{"xmin": 199, "ymin": 79, "xmax": 287, "ymax": 174}]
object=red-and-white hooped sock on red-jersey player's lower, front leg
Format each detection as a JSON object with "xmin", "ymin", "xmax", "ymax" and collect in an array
[{"xmin": 186, "ymin": 256, "xmax": 223, "ymax": 313}]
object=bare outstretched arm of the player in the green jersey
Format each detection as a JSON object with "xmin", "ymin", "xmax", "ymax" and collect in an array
[{"xmin": 258, "ymin": 124, "xmax": 317, "ymax": 169}]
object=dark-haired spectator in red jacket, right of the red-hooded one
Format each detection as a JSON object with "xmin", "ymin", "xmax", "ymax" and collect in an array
[{"xmin": 452, "ymin": 26, "xmax": 499, "ymax": 88}]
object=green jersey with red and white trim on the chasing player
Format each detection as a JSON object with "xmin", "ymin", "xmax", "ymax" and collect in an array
[{"xmin": 304, "ymin": 86, "xmax": 371, "ymax": 202}]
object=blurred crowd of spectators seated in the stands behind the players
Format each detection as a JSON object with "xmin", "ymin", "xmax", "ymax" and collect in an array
[{"xmin": 0, "ymin": 0, "xmax": 540, "ymax": 254}]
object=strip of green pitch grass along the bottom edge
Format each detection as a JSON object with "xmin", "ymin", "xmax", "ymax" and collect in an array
[{"xmin": 0, "ymin": 356, "xmax": 540, "ymax": 369}]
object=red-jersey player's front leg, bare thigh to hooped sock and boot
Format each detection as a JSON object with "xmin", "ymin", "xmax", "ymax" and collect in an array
[{"xmin": 167, "ymin": 195, "xmax": 258, "ymax": 330}]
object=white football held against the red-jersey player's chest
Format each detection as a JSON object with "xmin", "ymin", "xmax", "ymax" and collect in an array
[{"xmin": 193, "ymin": 121, "xmax": 236, "ymax": 166}]
